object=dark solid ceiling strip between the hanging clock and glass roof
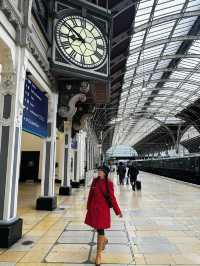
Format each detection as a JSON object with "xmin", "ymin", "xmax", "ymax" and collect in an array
[{"xmin": 90, "ymin": 0, "xmax": 136, "ymax": 150}]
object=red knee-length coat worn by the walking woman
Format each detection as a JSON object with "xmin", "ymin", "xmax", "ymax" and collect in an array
[{"xmin": 85, "ymin": 178, "xmax": 121, "ymax": 229}]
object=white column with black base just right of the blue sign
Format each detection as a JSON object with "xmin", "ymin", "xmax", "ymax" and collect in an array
[{"xmin": 36, "ymin": 94, "xmax": 58, "ymax": 211}]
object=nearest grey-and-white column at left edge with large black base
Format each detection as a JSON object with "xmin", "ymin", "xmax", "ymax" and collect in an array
[{"xmin": 0, "ymin": 48, "xmax": 27, "ymax": 248}]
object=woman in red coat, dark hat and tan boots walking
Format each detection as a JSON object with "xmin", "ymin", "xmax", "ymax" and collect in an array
[{"xmin": 85, "ymin": 166, "xmax": 122, "ymax": 265}]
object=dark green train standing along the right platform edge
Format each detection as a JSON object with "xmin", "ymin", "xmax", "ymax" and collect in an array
[{"xmin": 135, "ymin": 154, "xmax": 200, "ymax": 184}]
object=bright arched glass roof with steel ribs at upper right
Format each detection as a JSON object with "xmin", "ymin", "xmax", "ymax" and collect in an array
[{"xmin": 113, "ymin": 0, "xmax": 200, "ymax": 145}]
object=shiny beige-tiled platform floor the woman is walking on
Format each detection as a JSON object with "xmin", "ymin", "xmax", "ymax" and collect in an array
[{"xmin": 0, "ymin": 173, "xmax": 200, "ymax": 266}]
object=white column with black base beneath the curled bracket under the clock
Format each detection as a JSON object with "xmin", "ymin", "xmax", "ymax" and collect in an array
[{"xmin": 59, "ymin": 123, "xmax": 71, "ymax": 196}]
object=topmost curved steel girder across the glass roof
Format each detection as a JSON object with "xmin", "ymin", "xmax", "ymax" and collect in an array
[{"xmin": 132, "ymin": 10, "xmax": 200, "ymax": 33}]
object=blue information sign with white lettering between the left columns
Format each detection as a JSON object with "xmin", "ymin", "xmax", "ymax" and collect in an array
[{"xmin": 22, "ymin": 79, "xmax": 48, "ymax": 138}]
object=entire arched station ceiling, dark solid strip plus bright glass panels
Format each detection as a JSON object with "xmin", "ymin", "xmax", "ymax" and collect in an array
[{"xmin": 32, "ymin": 0, "xmax": 200, "ymax": 154}]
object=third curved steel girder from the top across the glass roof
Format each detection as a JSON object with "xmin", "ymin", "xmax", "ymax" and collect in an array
[{"xmin": 126, "ymin": 54, "xmax": 200, "ymax": 71}]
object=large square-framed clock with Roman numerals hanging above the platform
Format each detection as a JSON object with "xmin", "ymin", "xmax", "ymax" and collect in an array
[{"xmin": 50, "ymin": 0, "xmax": 112, "ymax": 82}]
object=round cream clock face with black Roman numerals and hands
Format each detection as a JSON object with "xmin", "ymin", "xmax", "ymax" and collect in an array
[{"xmin": 55, "ymin": 15, "xmax": 107, "ymax": 69}]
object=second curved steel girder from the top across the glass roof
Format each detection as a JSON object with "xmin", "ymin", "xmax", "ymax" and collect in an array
[{"xmin": 129, "ymin": 35, "xmax": 200, "ymax": 56}]
